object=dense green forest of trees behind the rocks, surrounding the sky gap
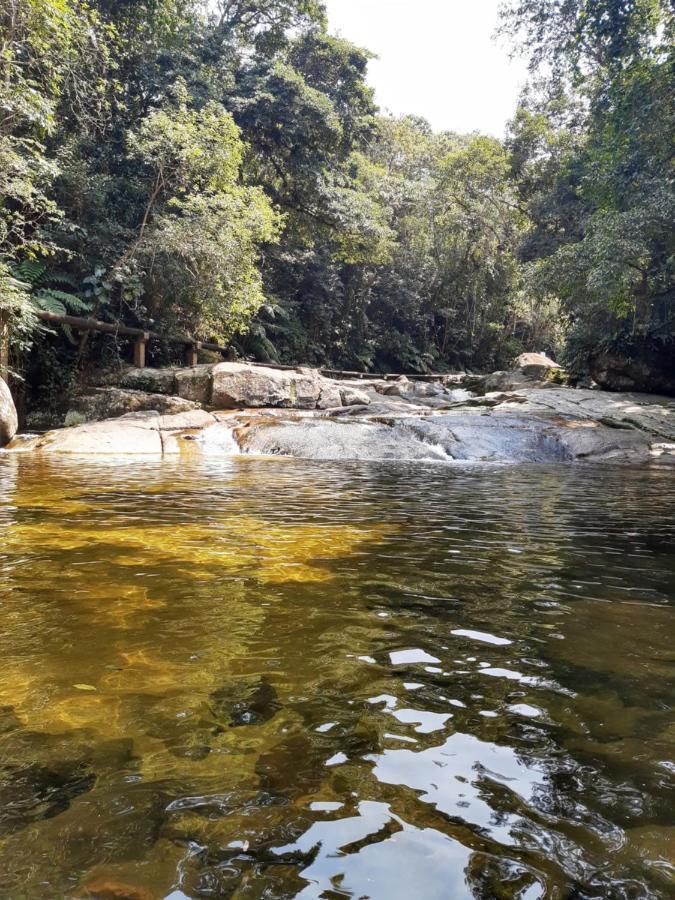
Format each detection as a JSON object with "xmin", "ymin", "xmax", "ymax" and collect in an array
[{"xmin": 0, "ymin": 0, "xmax": 675, "ymax": 406}]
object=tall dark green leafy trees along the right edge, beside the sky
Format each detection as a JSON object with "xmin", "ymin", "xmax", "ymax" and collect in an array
[{"xmin": 506, "ymin": 0, "xmax": 675, "ymax": 371}]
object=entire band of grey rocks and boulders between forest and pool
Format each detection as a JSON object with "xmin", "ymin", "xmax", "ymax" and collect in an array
[{"xmin": 5, "ymin": 355, "xmax": 675, "ymax": 464}]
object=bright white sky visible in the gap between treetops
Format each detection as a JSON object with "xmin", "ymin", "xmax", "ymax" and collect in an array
[{"xmin": 324, "ymin": 0, "xmax": 527, "ymax": 137}]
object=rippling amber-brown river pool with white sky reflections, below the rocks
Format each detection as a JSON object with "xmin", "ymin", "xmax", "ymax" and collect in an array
[{"xmin": 0, "ymin": 456, "xmax": 675, "ymax": 900}]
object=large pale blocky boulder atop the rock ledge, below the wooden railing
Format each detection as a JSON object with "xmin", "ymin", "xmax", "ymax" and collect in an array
[{"xmin": 211, "ymin": 363, "xmax": 322, "ymax": 409}]
